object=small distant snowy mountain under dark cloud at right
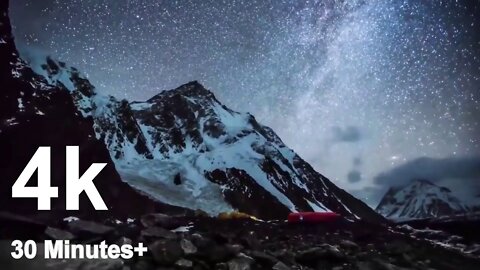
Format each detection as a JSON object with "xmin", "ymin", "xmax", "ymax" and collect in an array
[{"xmin": 376, "ymin": 180, "xmax": 469, "ymax": 220}]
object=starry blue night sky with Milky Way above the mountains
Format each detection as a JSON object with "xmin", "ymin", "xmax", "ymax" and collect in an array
[{"xmin": 10, "ymin": 0, "xmax": 480, "ymax": 206}]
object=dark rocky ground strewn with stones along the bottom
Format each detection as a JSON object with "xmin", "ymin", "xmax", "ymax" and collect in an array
[{"xmin": 0, "ymin": 214, "xmax": 480, "ymax": 270}]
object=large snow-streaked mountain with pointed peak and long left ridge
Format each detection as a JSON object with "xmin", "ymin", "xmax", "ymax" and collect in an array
[{"xmin": 35, "ymin": 58, "xmax": 380, "ymax": 221}]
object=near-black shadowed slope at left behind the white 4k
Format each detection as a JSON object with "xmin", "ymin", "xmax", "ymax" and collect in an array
[{"xmin": 0, "ymin": 1, "xmax": 183, "ymax": 219}]
